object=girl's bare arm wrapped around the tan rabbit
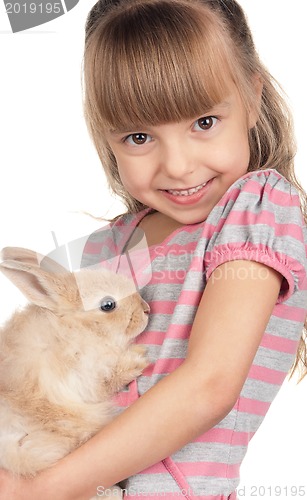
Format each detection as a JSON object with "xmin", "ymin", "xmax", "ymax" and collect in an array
[{"xmin": 0, "ymin": 261, "xmax": 282, "ymax": 500}]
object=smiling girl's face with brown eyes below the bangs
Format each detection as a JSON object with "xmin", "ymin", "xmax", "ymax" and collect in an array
[{"xmin": 107, "ymin": 86, "xmax": 255, "ymax": 224}]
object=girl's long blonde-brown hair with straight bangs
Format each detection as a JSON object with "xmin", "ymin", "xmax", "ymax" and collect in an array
[{"xmin": 83, "ymin": 0, "xmax": 307, "ymax": 374}]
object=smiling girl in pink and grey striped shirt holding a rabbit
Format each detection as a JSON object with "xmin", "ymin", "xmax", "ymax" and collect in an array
[{"xmin": 0, "ymin": 0, "xmax": 307, "ymax": 500}]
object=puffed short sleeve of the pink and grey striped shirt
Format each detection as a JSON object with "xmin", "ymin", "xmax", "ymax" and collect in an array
[{"xmin": 204, "ymin": 169, "xmax": 307, "ymax": 302}]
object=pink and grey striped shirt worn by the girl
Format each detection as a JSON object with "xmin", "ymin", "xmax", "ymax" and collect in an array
[{"xmin": 83, "ymin": 169, "xmax": 307, "ymax": 500}]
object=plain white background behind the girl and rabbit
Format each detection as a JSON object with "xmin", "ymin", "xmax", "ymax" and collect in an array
[{"xmin": 0, "ymin": 0, "xmax": 307, "ymax": 500}]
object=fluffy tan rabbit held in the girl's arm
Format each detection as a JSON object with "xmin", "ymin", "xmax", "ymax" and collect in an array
[{"xmin": 0, "ymin": 247, "xmax": 149, "ymax": 497}]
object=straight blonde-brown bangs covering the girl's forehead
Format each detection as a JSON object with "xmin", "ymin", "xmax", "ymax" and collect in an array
[{"xmin": 88, "ymin": 0, "xmax": 234, "ymax": 130}]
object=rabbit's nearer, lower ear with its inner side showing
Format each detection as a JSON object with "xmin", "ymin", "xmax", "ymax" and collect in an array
[{"xmin": 0, "ymin": 260, "xmax": 67, "ymax": 310}]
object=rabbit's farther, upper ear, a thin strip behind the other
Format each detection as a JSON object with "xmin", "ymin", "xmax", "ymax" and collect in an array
[{"xmin": 1, "ymin": 247, "xmax": 67, "ymax": 273}]
